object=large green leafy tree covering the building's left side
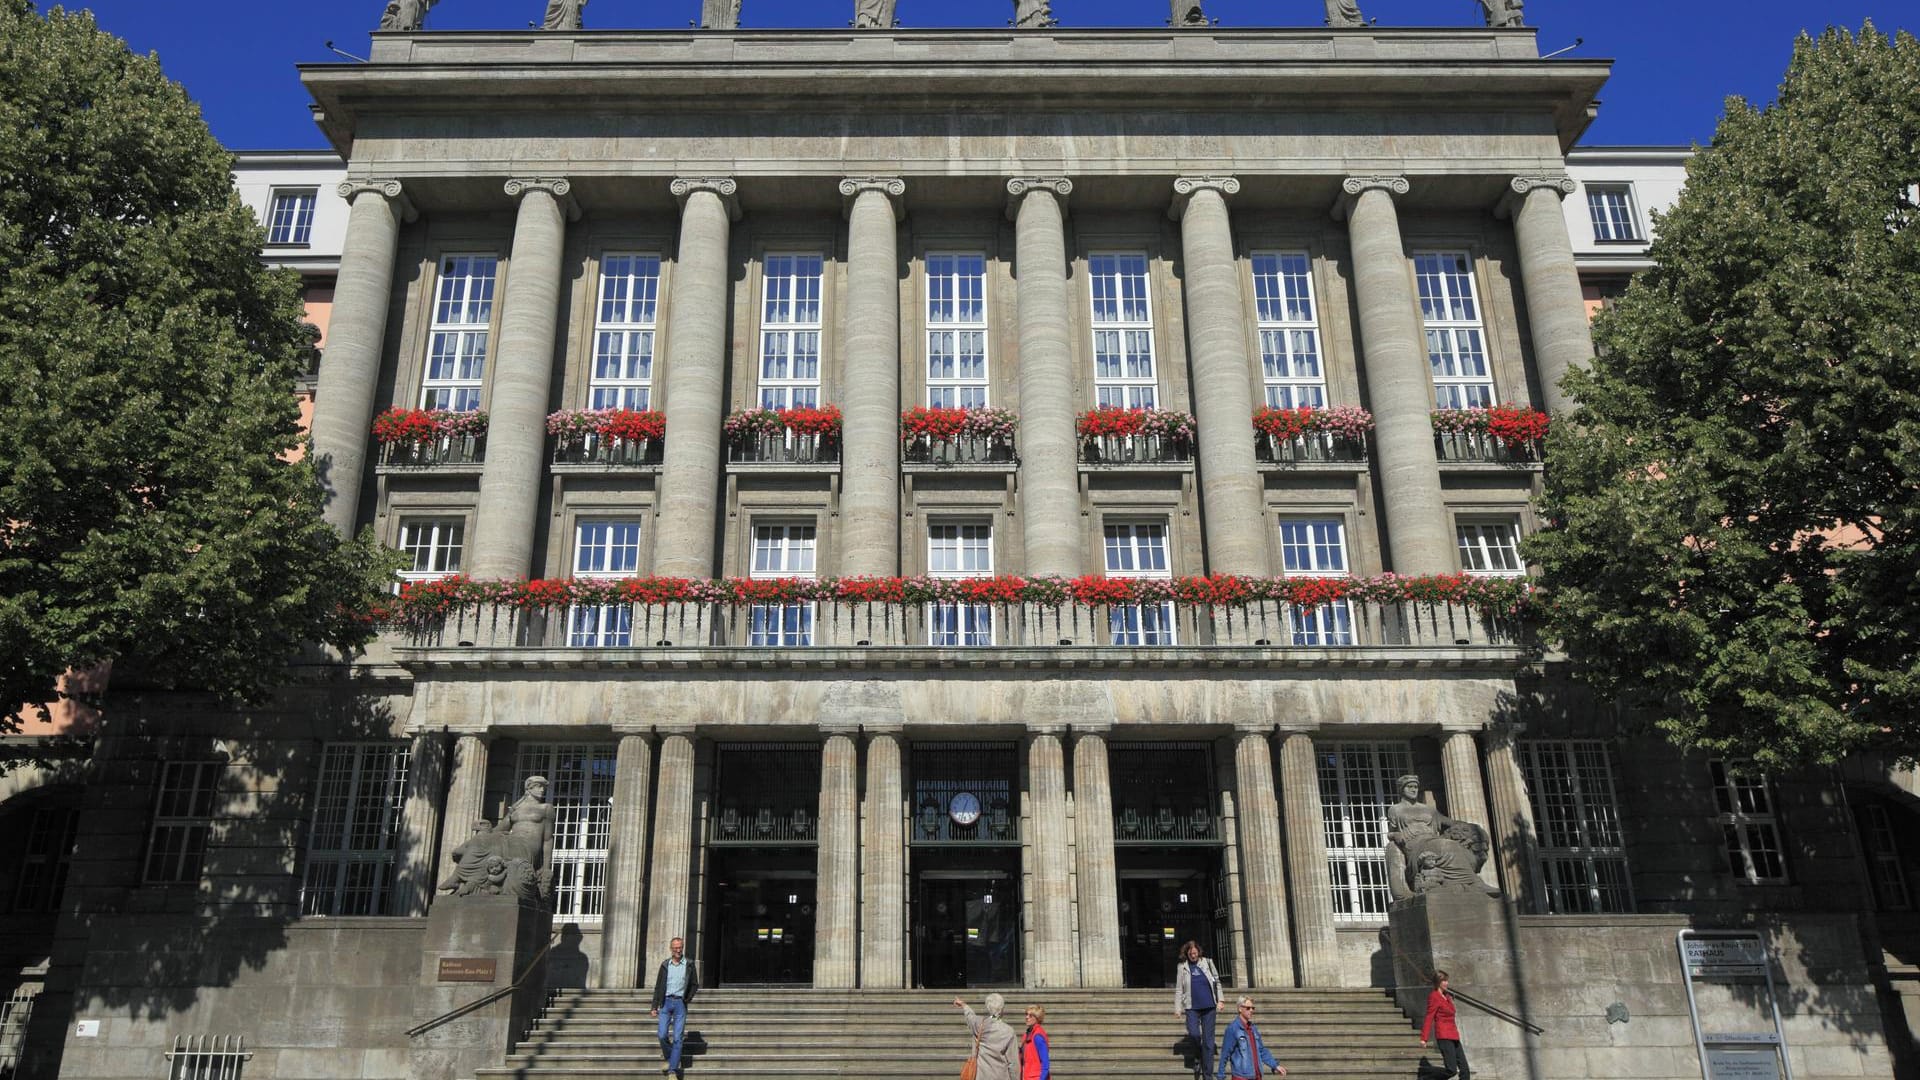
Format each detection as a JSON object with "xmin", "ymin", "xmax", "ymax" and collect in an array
[{"xmin": 0, "ymin": 0, "xmax": 388, "ymax": 730}]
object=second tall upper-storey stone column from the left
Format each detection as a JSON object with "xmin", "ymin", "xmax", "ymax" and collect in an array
[{"xmin": 467, "ymin": 179, "xmax": 572, "ymax": 578}]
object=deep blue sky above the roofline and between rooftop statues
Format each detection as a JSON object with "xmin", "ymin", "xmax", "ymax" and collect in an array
[{"xmin": 40, "ymin": 0, "xmax": 1920, "ymax": 150}]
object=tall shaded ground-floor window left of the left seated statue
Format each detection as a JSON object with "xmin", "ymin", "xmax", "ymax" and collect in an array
[{"xmin": 300, "ymin": 742, "xmax": 409, "ymax": 915}]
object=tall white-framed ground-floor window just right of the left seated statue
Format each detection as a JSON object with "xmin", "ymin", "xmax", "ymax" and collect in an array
[{"xmin": 513, "ymin": 742, "xmax": 614, "ymax": 922}]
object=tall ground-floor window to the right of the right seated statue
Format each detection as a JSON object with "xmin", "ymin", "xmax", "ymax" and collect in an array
[{"xmin": 1517, "ymin": 738, "xmax": 1634, "ymax": 915}]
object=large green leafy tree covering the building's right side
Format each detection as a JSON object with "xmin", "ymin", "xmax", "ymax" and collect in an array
[{"xmin": 1528, "ymin": 23, "xmax": 1920, "ymax": 767}]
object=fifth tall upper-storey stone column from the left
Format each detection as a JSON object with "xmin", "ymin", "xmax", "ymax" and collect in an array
[{"xmin": 1006, "ymin": 177, "xmax": 1081, "ymax": 577}]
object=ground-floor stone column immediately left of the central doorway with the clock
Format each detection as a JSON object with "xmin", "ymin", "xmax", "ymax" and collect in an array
[{"xmin": 860, "ymin": 732, "xmax": 906, "ymax": 990}]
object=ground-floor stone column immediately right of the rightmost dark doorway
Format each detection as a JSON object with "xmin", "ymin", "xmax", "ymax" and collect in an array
[{"xmin": 1233, "ymin": 730, "xmax": 1294, "ymax": 986}]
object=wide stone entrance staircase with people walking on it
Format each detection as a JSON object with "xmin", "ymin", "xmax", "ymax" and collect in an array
[{"xmin": 478, "ymin": 988, "xmax": 1438, "ymax": 1080}]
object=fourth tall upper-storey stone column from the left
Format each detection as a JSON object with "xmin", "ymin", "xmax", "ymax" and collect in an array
[{"xmin": 837, "ymin": 177, "xmax": 906, "ymax": 576}]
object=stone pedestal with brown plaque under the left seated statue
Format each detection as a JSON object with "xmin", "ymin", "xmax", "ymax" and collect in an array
[{"xmin": 409, "ymin": 896, "xmax": 553, "ymax": 1080}]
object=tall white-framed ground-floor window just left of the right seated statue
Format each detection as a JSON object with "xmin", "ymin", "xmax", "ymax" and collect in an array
[{"xmin": 1313, "ymin": 742, "xmax": 1413, "ymax": 922}]
